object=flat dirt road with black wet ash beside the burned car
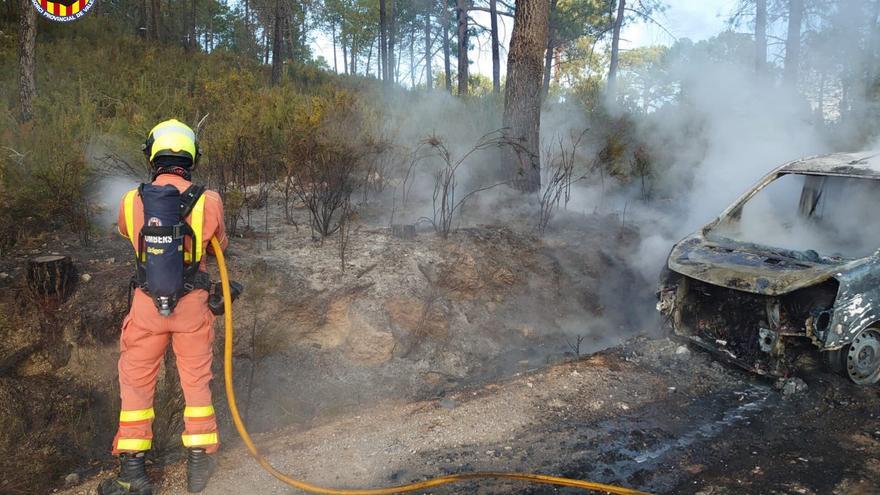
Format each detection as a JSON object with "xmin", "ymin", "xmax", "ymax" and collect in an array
[{"xmin": 63, "ymin": 339, "xmax": 880, "ymax": 495}]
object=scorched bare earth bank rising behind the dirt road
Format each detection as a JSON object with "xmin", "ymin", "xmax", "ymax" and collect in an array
[{"xmin": 0, "ymin": 203, "xmax": 653, "ymax": 493}]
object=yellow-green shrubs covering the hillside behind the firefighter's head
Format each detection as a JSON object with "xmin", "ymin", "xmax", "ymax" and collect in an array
[{"xmin": 0, "ymin": 18, "xmax": 379, "ymax": 249}]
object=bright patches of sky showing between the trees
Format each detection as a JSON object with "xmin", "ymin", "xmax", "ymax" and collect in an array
[{"xmin": 313, "ymin": 0, "xmax": 738, "ymax": 83}]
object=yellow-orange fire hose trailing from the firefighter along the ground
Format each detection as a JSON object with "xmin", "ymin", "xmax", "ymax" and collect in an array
[{"xmin": 211, "ymin": 239, "xmax": 649, "ymax": 495}]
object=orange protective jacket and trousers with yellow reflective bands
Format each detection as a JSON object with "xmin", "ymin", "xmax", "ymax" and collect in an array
[{"xmin": 113, "ymin": 174, "xmax": 229, "ymax": 454}]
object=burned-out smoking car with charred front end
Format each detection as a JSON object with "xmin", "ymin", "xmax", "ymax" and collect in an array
[{"xmin": 657, "ymin": 152, "xmax": 880, "ymax": 384}]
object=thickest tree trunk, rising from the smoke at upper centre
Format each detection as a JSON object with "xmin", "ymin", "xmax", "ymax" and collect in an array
[{"xmin": 501, "ymin": 0, "xmax": 550, "ymax": 192}]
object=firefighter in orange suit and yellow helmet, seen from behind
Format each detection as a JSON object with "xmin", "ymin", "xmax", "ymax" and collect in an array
[{"xmin": 98, "ymin": 119, "xmax": 228, "ymax": 495}]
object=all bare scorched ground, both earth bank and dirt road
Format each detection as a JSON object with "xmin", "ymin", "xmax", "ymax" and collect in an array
[{"xmin": 0, "ymin": 199, "xmax": 880, "ymax": 495}]
